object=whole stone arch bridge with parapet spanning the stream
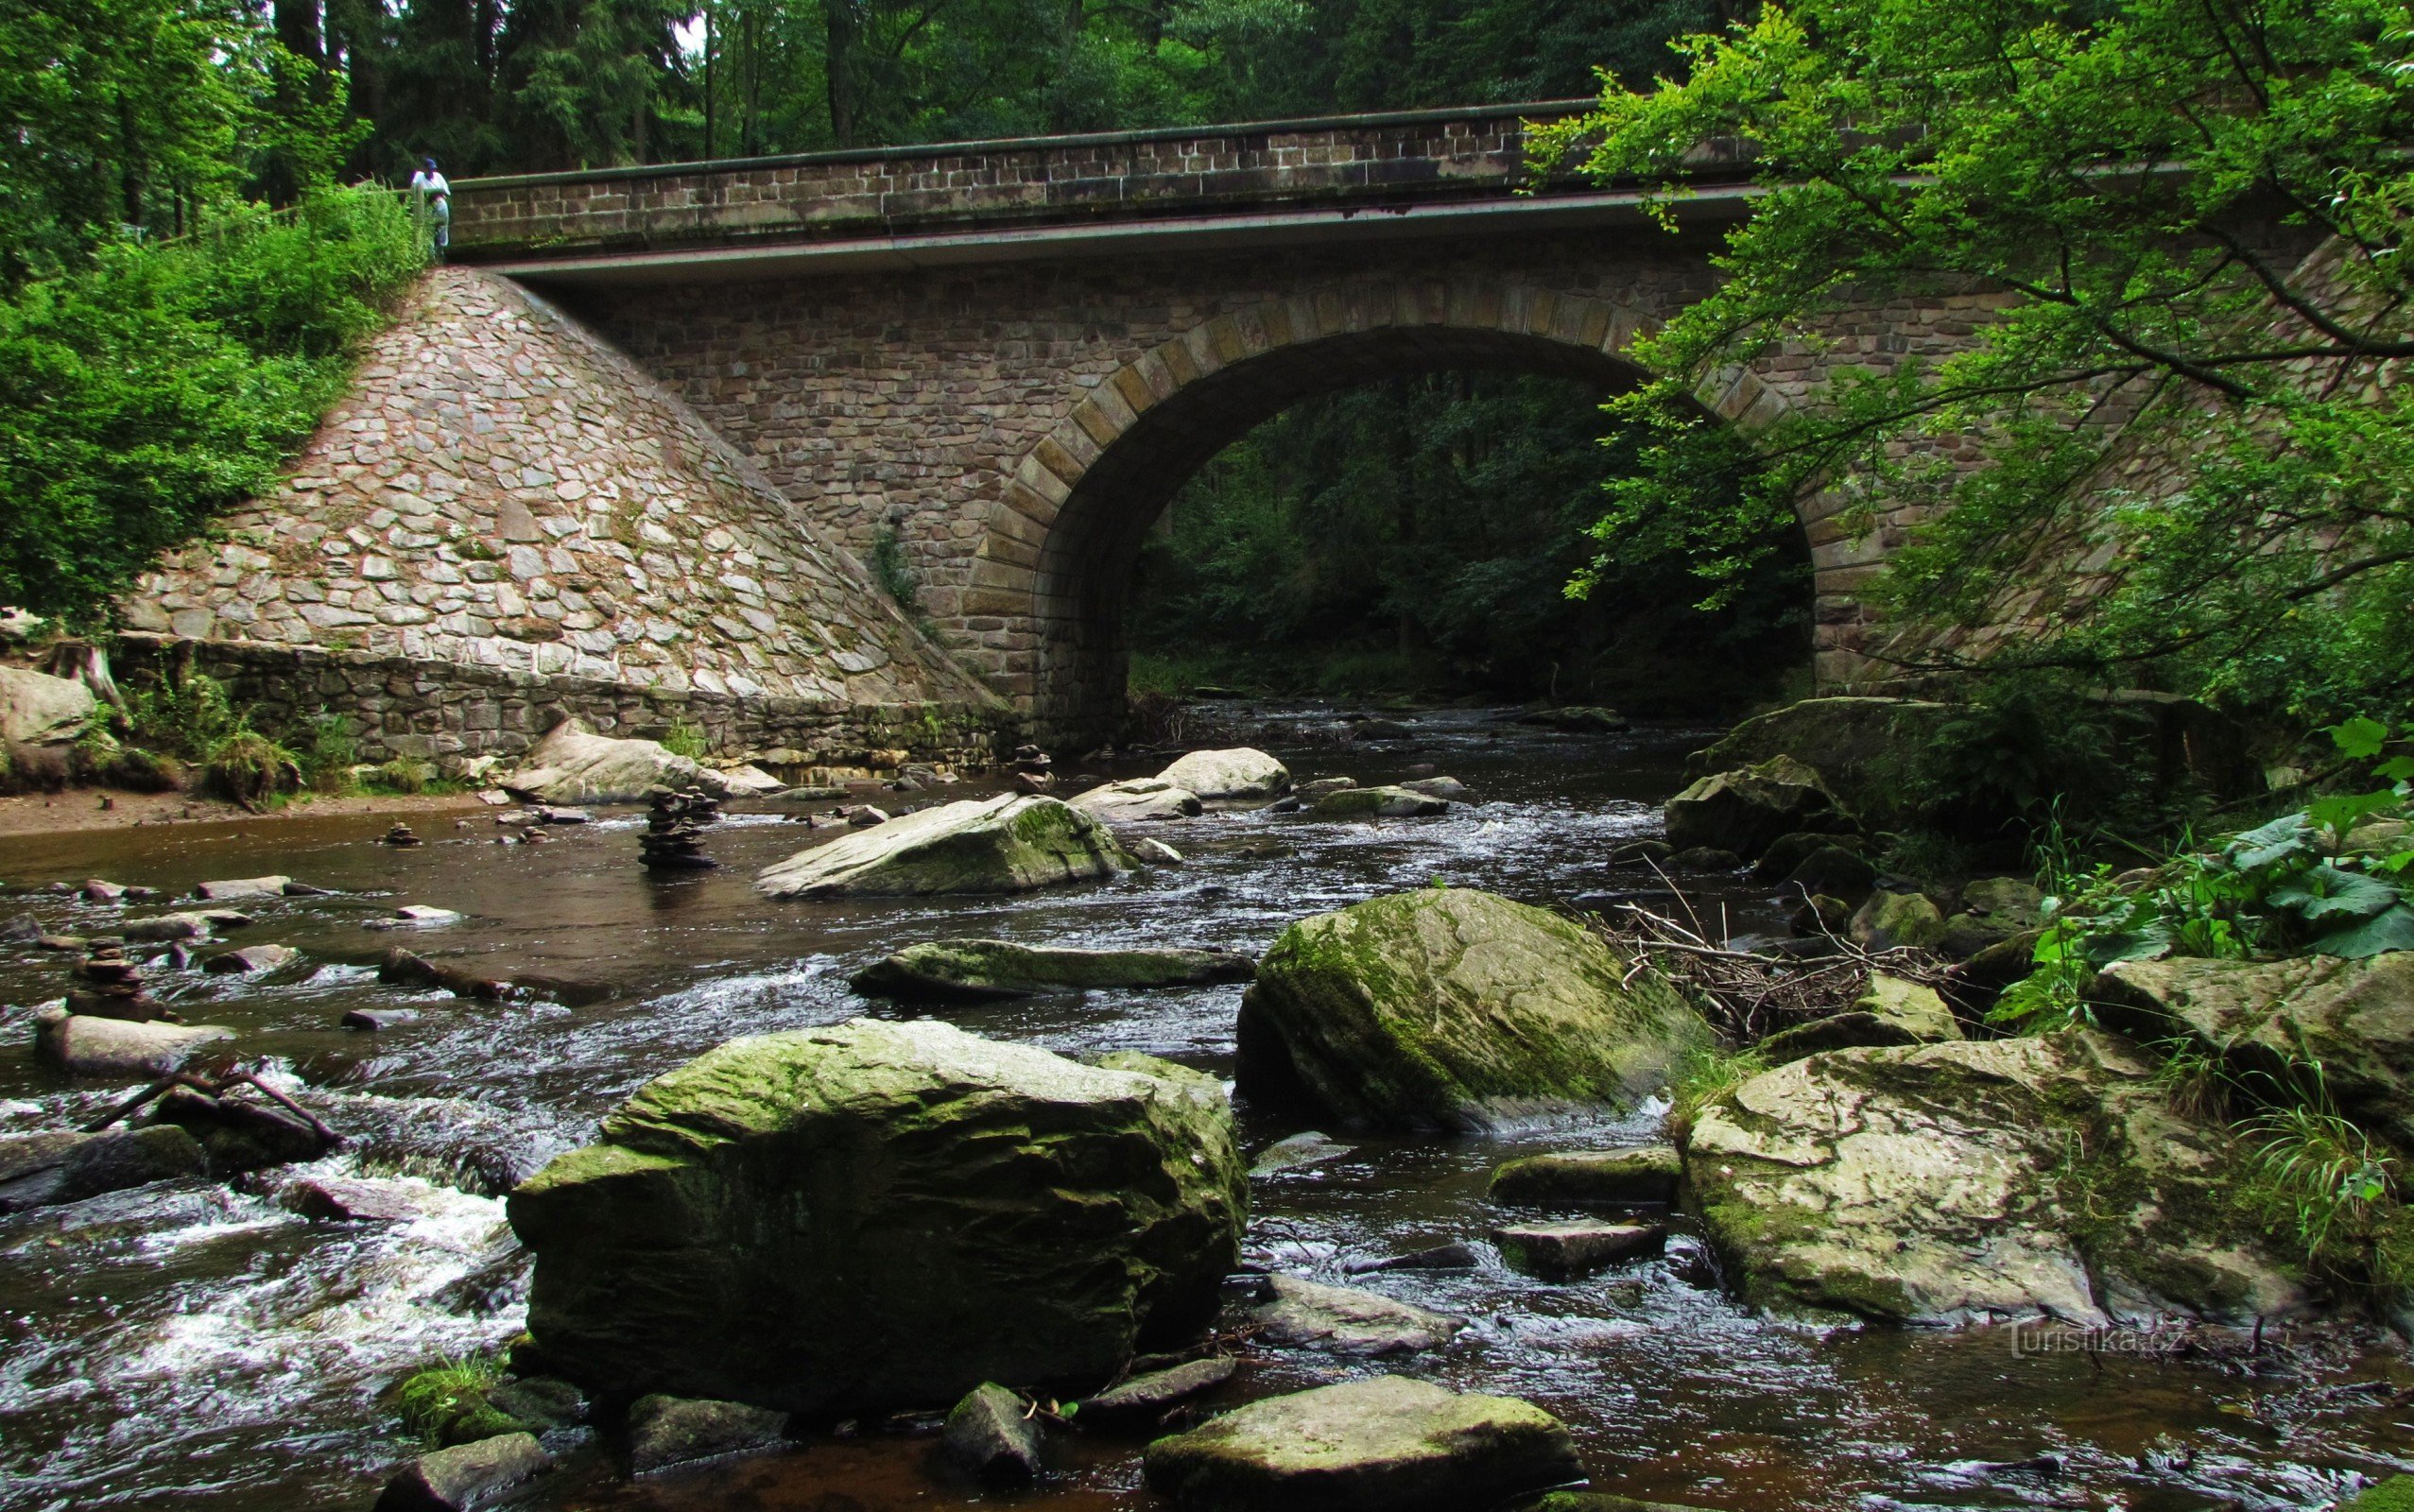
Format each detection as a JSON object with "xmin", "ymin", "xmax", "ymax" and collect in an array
[{"xmin": 454, "ymin": 104, "xmax": 1984, "ymax": 739}]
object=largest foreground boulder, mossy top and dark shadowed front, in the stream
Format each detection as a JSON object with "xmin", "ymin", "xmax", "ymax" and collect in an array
[{"xmin": 509, "ymin": 1020, "xmax": 1248, "ymax": 1413}]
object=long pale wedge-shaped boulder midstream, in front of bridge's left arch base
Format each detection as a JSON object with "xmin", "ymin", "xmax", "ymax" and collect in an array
[{"xmin": 755, "ymin": 795, "xmax": 1137, "ymax": 899}]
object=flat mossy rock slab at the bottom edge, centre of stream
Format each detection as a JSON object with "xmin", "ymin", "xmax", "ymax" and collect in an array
[{"xmin": 1145, "ymin": 1377, "xmax": 1583, "ymax": 1512}]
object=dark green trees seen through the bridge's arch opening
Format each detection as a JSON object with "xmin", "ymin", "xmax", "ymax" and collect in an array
[{"xmin": 1129, "ymin": 374, "xmax": 1808, "ymax": 710}]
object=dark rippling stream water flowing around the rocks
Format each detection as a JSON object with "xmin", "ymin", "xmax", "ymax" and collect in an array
[{"xmin": 0, "ymin": 710, "xmax": 2414, "ymax": 1512}]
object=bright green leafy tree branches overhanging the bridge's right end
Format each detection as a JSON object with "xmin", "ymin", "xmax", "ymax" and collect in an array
[{"xmin": 1543, "ymin": 0, "xmax": 2414, "ymax": 720}]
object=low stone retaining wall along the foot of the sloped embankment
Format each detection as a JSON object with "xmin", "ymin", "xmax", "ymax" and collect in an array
[{"xmin": 111, "ymin": 635, "xmax": 1016, "ymax": 768}]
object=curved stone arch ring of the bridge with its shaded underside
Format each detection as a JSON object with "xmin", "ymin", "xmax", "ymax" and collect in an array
[{"xmin": 956, "ymin": 283, "xmax": 1786, "ymax": 742}]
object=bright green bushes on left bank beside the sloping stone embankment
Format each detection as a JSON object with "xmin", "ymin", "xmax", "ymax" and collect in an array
[{"xmin": 0, "ymin": 191, "xmax": 418, "ymax": 621}]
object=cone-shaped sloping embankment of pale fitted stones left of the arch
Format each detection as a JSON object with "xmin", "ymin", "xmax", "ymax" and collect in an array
[{"xmin": 121, "ymin": 268, "xmax": 999, "ymax": 751}]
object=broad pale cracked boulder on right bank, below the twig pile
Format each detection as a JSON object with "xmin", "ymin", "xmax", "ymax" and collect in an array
[{"xmin": 1685, "ymin": 1029, "xmax": 2305, "ymax": 1324}]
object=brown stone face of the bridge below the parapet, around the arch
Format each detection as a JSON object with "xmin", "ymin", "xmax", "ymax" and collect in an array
[{"xmin": 577, "ymin": 230, "xmax": 1992, "ymax": 733}]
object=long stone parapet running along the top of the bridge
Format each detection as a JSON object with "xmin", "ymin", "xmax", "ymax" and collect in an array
[{"xmin": 454, "ymin": 99, "xmax": 1737, "ymax": 261}]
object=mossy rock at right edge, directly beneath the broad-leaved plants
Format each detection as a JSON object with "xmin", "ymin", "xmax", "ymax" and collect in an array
[{"xmin": 2088, "ymin": 949, "xmax": 2414, "ymax": 1145}]
